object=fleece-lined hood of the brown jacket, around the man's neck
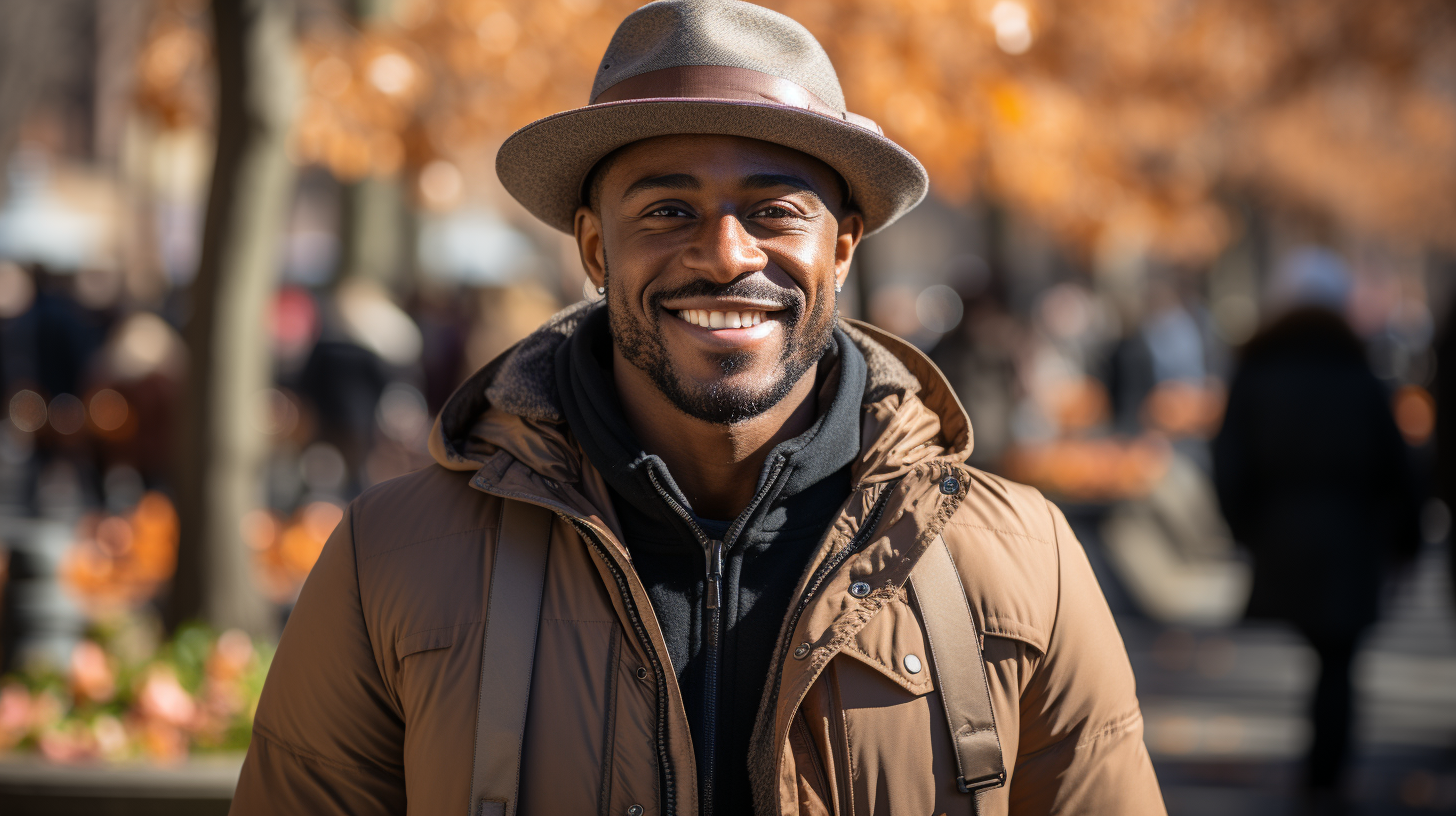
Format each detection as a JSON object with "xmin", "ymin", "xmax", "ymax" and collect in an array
[{"xmin": 430, "ymin": 302, "xmax": 971, "ymax": 489}]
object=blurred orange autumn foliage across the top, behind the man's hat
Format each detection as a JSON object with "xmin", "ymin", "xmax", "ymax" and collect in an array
[{"xmin": 133, "ymin": 0, "xmax": 1456, "ymax": 262}]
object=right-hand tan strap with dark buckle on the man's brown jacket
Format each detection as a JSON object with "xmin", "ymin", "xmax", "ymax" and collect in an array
[{"xmin": 910, "ymin": 536, "xmax": 1006, "ymax": 813}]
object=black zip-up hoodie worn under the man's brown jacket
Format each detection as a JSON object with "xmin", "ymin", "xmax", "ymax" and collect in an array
[{"xmin": 556, "ymin": 309, "xmax": 866, "ymax": 815}]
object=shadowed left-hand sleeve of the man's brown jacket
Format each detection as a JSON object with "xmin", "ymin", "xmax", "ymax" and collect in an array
[{"xmin": 230, "ymin": 507, "xmax": 405, "ymax": 816}]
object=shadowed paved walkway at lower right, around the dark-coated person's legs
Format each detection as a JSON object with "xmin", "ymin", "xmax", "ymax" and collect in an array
[{"xmin": 1100, "ymin": 538, "xmax": 1456, "ymax": 816}]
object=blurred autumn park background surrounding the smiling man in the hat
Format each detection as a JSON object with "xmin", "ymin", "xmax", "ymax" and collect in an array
[{"xmin": 0, "ymin": 0, "xmax": 1456, "ymax": 816}]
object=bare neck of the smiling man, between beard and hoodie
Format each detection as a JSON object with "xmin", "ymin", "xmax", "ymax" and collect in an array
[{"xmin": 612, "ymin": 351, "xmax": 818, "ymax": 519}]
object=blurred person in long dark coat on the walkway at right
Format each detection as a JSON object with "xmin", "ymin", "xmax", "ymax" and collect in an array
[{"xmin": 1213, "ymin": 298, "xmax": 1420, "ymax": 790}]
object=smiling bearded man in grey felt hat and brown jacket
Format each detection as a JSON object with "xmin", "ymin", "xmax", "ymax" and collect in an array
[{"xmin": 233, "ymin": 0, "xmax": 1163, "ymax": 816}]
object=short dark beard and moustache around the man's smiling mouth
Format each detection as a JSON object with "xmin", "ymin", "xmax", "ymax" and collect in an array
[{"xmin": 606, "ymin": 260, "xmax": 839, "ymax": 425}]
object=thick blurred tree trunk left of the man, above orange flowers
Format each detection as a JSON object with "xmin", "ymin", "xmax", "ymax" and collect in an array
[{"xmin": 166, "ymin": 0, "xmax": 297, "ymax": 632}]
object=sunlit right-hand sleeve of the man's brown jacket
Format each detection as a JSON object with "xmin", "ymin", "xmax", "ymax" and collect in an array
[{"xmin": 1010, "ymin": 503, "xmax": 1166, "ymax": 816}]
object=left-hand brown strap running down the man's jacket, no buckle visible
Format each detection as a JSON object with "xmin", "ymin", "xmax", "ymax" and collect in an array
[{"xmin": 469, "ymin": 498, "xmax": 552, "ymax": 816}]
